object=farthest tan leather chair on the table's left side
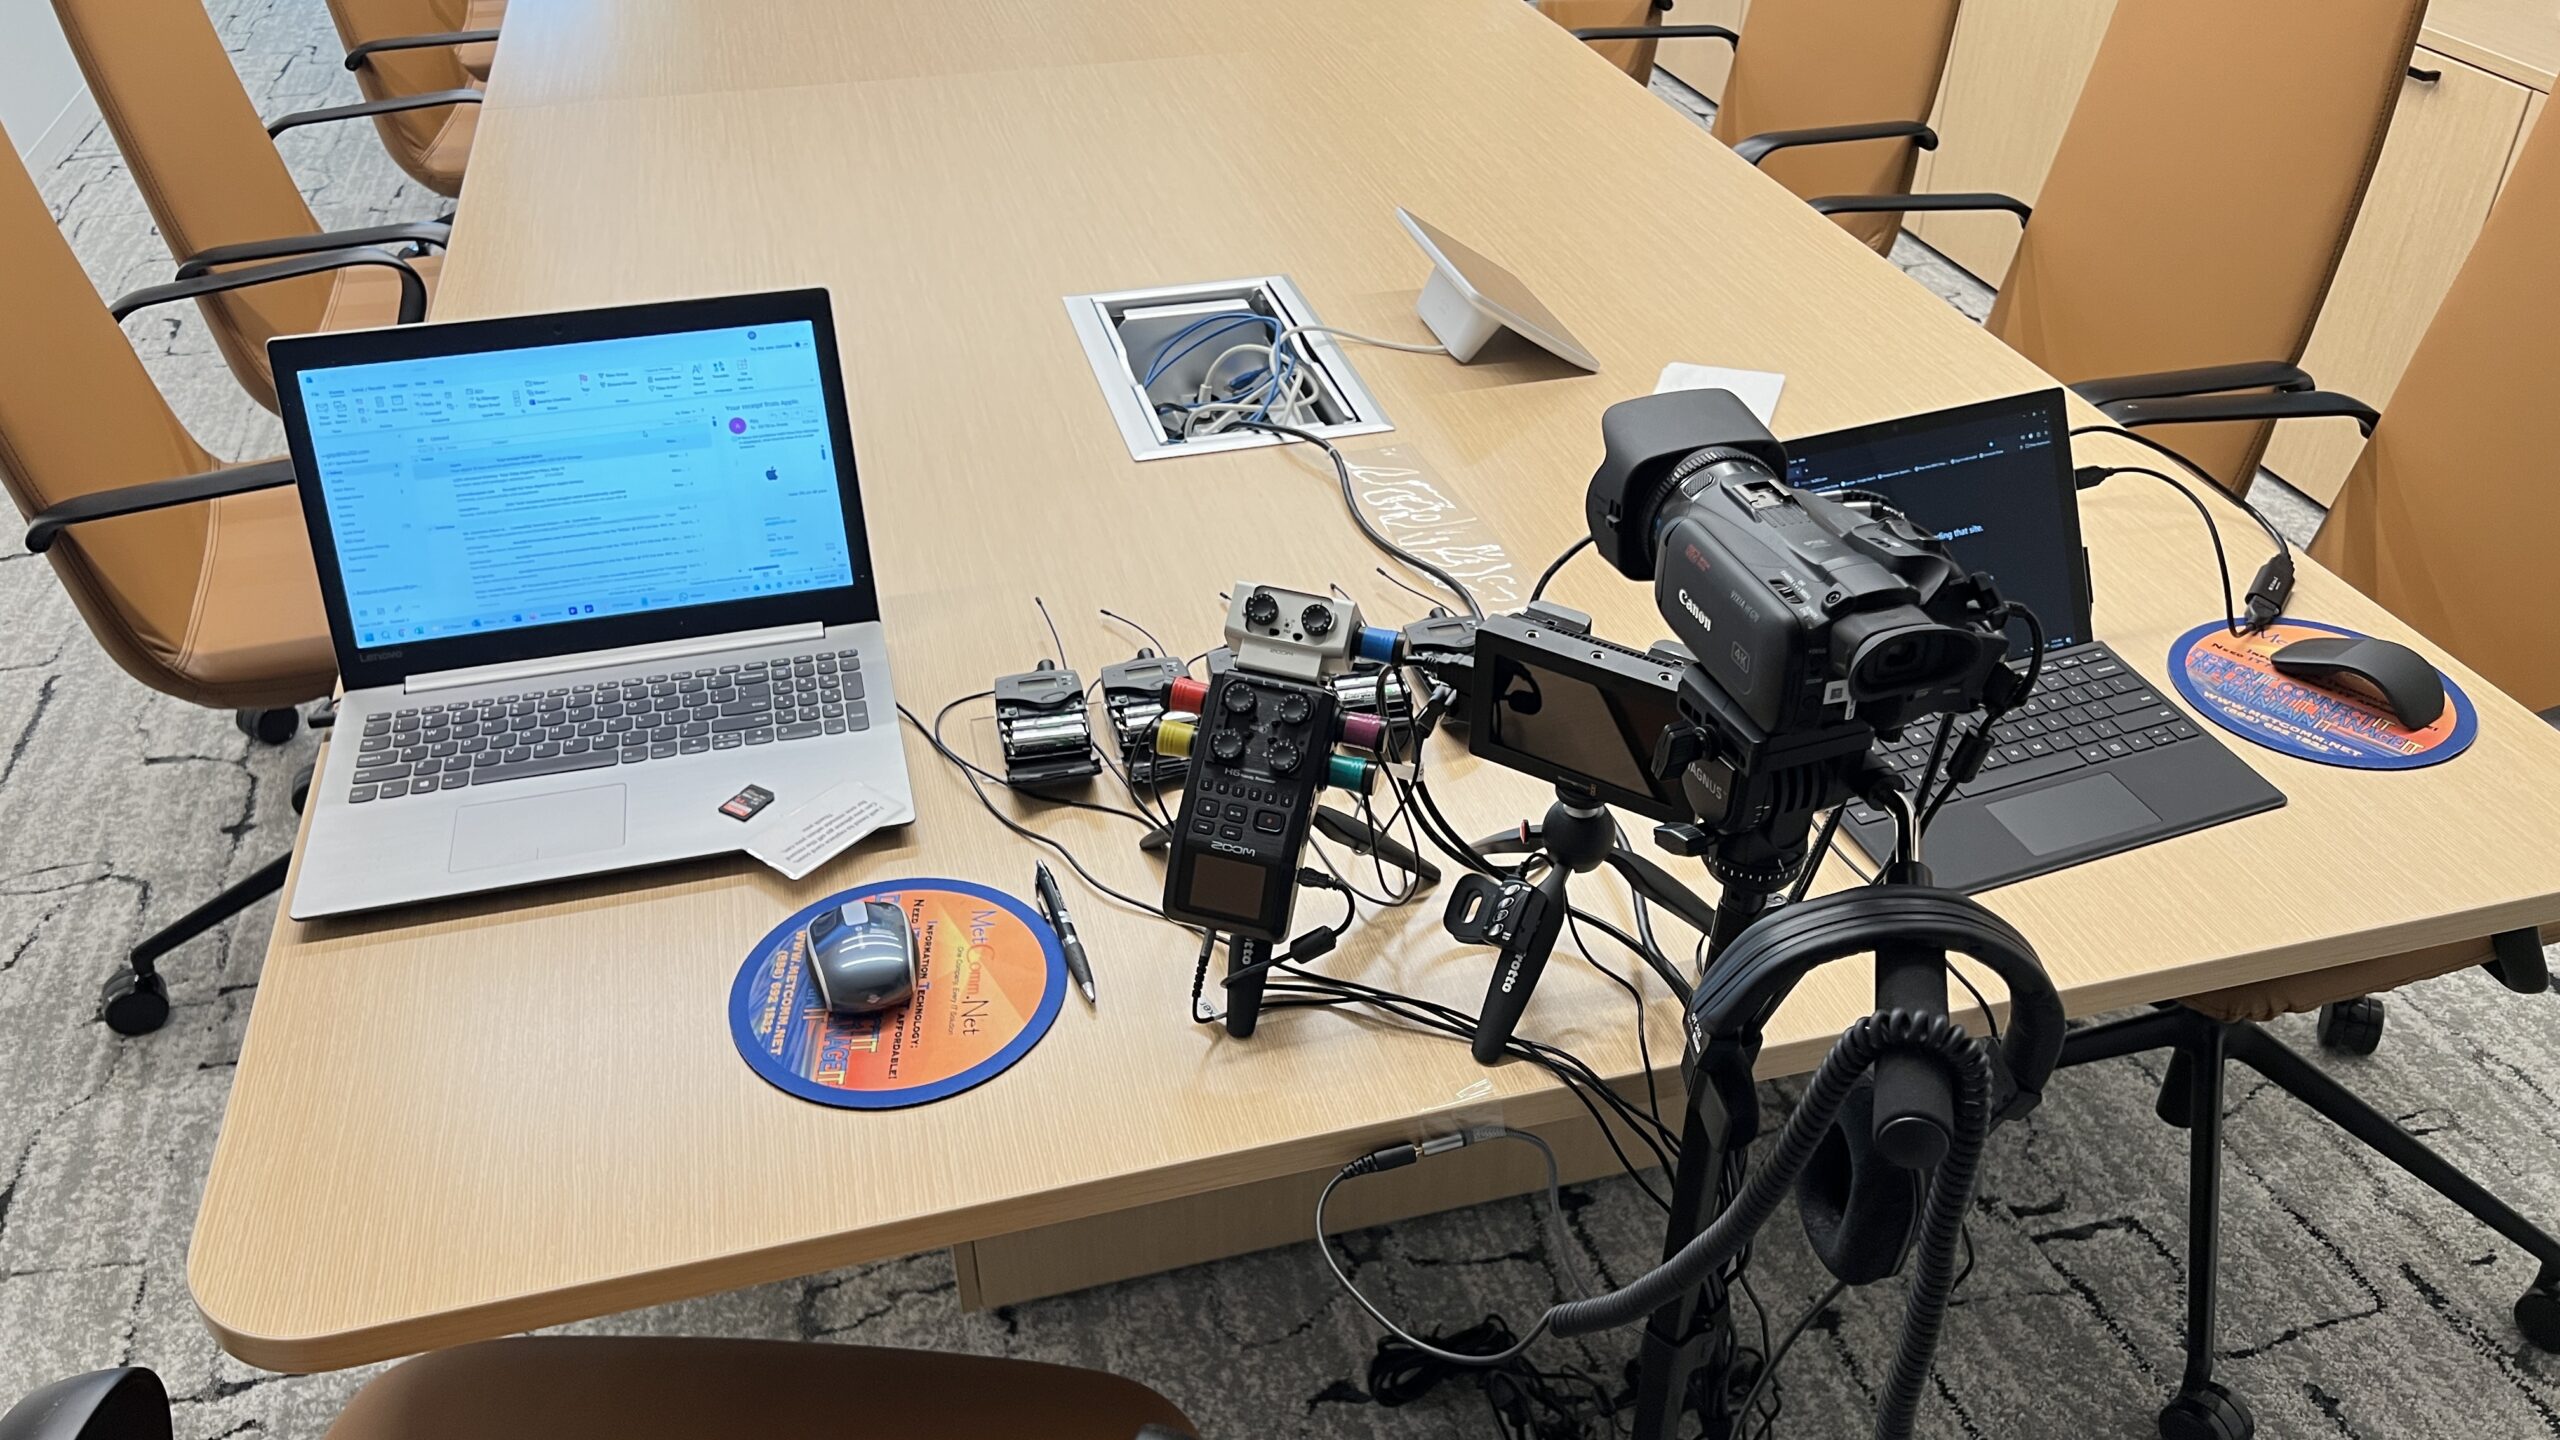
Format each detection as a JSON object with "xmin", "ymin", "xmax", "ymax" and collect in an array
[{"xmin": 328, "ymin": 0, "xmax": 497, "ymax": 195}]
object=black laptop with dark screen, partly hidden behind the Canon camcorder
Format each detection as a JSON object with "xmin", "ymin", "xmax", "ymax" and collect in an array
[{"xmin": 1787, "ymin": 389, "xmax": 2284, "ymax": 892}]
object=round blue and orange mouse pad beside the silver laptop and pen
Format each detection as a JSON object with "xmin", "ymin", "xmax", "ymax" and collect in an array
[{"xmin": 730, "ymin": 879, "xmax": 1068, "ymax": 1109}]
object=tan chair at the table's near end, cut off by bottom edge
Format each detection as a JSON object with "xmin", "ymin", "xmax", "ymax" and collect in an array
[{"xmin": 0, "ymin": 1335, "xmax": 1193, "ymax": 1440}]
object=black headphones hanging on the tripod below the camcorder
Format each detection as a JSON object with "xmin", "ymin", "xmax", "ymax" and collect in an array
[{"xmin": 1687, "ymin": 887, "xmax": 2063, "ymax": 1286}]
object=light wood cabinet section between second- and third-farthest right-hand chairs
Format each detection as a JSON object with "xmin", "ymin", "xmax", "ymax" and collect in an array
[{"xmin": 1907, "ymin": 0, "xmax": 2115, "ymax": 284}]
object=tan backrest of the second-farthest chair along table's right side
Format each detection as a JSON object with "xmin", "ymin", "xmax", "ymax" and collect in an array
[{"xmin": 1715, "ymin": 0, "xmax": 1958, "ymax": 254}]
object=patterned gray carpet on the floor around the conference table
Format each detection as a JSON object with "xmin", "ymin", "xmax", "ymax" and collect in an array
[{"xmin": 0, "ymin": 0, "xmax": 2560, "ymax": 1440}]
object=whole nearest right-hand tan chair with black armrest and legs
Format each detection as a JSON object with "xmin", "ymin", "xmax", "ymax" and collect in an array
[{"xmin": 2063, "ymin": 114, "xmax": 2560, "ymax": 1435}]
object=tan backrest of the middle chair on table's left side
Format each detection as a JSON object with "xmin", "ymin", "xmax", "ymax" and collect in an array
[{"xmin": 54, "ymin": 0, "xmax": 333, "ymax": 410}]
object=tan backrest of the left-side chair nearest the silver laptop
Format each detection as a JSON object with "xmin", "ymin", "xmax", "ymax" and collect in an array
[{"xmin": 0, "ymin": 141, "xmax": 215, "ymax": 682}]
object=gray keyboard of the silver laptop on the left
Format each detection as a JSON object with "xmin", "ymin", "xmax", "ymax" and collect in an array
[{"xmin": 346, "ymin": 648, "xmax": 870, "ymax": 805}]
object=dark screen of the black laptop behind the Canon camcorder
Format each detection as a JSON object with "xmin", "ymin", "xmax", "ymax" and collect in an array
[{"xmin": 1787, "ymin": 389, "xmax": 2089, "ymax": 656}]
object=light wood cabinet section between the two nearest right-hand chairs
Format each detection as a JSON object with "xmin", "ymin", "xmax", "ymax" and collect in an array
[{"xmin": 2263, "ymin": 49, "xmax": 2532, "ymax": 505}]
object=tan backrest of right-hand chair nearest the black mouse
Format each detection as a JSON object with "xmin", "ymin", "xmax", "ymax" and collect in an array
[{"xmin": 2296, "ymin": 123, "xmax": 2560, "ymax": 710}]
